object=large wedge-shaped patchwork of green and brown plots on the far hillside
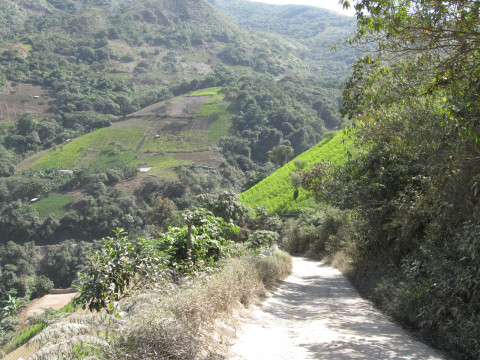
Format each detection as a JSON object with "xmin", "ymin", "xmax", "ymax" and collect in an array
[{"xmin": 17, "ymin": 87, "xmax": 230, "ymax": 174}]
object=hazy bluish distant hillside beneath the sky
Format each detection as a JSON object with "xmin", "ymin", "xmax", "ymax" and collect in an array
[{"xmin": 208, "ymin": 0, "xmax": 361, "ymax": 78}]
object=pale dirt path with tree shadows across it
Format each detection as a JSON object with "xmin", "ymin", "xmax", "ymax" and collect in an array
[{"xmin": 229, "ymin": 258, "xmax": 445, "ymax": 360}]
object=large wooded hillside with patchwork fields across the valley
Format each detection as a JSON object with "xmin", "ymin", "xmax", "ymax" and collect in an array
[{"xmin": 0, "ymin": 0, "xmax": 354, "ymax": 334}]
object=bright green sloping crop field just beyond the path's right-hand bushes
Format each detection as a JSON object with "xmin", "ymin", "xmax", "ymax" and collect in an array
[{"xmin": 240, "ymin": 131, "xmax": 355, "ymax": 213}]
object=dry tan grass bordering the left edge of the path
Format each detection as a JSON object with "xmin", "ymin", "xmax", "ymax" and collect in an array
[{"xmin": 24, "ymin": 250, "xmax": 292, "ymax": 360}]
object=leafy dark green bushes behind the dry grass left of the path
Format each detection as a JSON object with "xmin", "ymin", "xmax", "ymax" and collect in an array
[{"xmin": 79, "ymin": 209, "xmax": 239, "ymax": 313}]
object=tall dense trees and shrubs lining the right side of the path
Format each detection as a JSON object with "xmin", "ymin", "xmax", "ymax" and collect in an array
[{"xmin": 280, "ymin": 0, "xmax": 480, "ymax": 359}]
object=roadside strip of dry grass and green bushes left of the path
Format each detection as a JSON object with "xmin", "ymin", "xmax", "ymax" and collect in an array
[{"xmin": 5, "ymin": 204, "xmax": 291, "ymax": 359}]
